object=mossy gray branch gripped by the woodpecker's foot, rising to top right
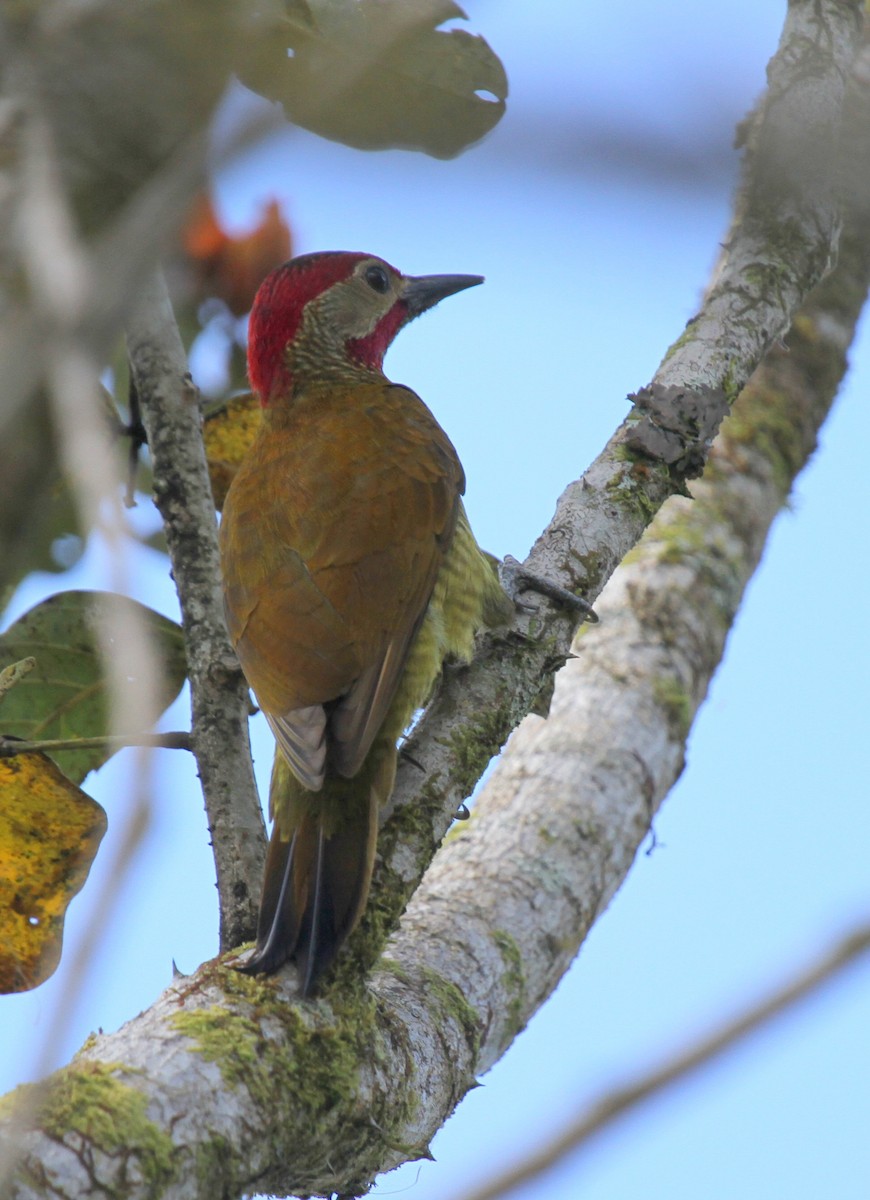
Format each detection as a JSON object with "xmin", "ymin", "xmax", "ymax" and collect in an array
[{"xmin": 370, "ymin": 0, "xmax": 860, "ymax": 936}]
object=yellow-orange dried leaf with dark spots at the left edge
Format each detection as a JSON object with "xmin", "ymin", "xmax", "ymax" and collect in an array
[{"xmin": 0, "ymin": 755, "xmax": 106, "ymax": 992}]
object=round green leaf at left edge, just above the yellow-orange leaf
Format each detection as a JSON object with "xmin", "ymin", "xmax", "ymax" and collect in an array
[{"xmin": 0, "ymin": 592, "xmax": 187, "ymax": 784}]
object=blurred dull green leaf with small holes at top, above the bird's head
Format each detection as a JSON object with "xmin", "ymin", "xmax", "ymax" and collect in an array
[{"xmin": 241, "ymin": 0, "xmax": 508, "ymax": 158}]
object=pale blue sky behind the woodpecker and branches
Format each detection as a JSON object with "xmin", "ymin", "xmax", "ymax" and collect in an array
[{"xmin": 0, "ymin": 7, "xmax": 870, "ymax": 1200}]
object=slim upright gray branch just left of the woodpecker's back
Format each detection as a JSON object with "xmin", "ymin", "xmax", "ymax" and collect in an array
[{"xmin": 127, "ymin": 276, "xmax": 265, "ymax": 949}]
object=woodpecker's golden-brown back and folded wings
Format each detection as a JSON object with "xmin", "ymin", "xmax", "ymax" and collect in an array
[{"xmin": 221, "ymin": 384, "xmax": 464, "ymax": 790}]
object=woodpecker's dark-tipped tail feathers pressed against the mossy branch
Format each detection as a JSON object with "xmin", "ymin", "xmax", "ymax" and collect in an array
[{"xmin": 241, "ymin": 745, "xmax": 388, "ymax": 996}]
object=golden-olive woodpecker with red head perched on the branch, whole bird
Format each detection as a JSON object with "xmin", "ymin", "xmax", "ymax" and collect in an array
[{"xmin": 221, "ymin": 252, "xmax": 512, "ymax": 994}]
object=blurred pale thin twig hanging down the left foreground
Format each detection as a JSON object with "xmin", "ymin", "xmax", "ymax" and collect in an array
[{"xmin": 0, "ymin": 72, "xmax": 166, "ymax": 1190}]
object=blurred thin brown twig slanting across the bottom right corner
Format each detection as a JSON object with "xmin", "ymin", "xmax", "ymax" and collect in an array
[{"xmin": 451, "ymin": 925, "xmax": 870, "ymax": 1200}]
